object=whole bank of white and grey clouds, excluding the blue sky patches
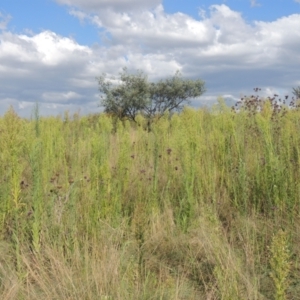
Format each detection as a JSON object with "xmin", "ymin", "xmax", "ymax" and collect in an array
[{"xmin": 0, "ymin": 4, "xmax": 300, "ymax": 118}]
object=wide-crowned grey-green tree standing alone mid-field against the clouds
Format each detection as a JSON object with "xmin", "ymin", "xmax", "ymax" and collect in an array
[{"xmin": 97, "ymin": 68, "xmax": 205, "ymax": 124}]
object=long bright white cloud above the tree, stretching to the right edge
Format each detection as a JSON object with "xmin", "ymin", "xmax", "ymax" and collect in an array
[{"xmin": 71, "ymin": 5, "xmax": 300, "ymax": 74}]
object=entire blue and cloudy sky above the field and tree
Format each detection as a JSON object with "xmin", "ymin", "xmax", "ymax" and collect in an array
[{"xmin": 0, "ymin": 0, "xmax": 300, "ymax": 117}]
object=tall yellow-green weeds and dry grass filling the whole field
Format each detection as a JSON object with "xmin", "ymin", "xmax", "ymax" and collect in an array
[{"xmin": 0, "ymin": 88, "xmax": 300, "ymax": 300}]
